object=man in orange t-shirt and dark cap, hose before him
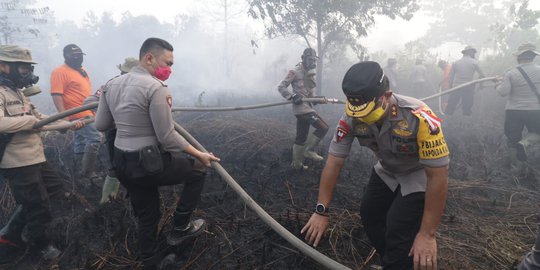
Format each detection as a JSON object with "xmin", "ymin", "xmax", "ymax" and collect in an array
[{"xmin": 51, "ymin": 44, "xmax": 101, "ymax": 179}]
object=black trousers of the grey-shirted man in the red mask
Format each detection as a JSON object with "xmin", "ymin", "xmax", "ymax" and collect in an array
[{"xmin": 114, "ymin": 149, "xmax": 206, "ymax": 259}]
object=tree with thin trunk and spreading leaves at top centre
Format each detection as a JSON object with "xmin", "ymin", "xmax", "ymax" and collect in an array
[{"xmin": 248, "ymin": 0, "xmax": 418, "ymax": 95}]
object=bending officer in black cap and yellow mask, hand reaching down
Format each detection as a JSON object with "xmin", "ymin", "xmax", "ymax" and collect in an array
[{"xmin": 302, "ymin": 61, "xmax": 449, "ymax": 270}]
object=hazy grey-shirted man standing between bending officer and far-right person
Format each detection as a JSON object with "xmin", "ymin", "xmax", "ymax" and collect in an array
[{"xmin": 444, "ymin": 46, "xmax": 485, "ymax": 116}]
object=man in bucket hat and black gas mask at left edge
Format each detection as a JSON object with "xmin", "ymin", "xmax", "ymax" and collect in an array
[{"xmin": 0, "ymin": 45, "xmax": 73, "ymax": 260}]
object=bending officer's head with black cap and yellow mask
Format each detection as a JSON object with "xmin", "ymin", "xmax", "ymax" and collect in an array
[{"xmin": 341, "ymin": 61, "xmax": 387, "ymax": 117}]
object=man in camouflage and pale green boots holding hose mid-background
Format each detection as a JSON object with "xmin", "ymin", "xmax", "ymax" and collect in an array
[{"xmin": 278, "ymin": 48, "xmax": 328, "ymax": 169}]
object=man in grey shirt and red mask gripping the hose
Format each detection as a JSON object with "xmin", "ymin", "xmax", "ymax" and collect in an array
[{"xmin": 96, "ymin": 38, "xmax": 219, "ymax": 268}]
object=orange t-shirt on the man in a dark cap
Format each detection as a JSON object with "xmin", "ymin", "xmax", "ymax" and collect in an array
[{"xmin": 51, "ymin": 64, "xmax": 94, "ymax": 120}]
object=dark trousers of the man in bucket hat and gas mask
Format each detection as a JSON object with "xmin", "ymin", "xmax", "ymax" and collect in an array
[{"xmin": 0, "ymin": 162, "xmax": 64, "ymax": 248}]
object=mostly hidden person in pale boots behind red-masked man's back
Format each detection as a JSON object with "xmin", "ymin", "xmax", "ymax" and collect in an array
[{"xmin": 84, "ymin": 57, "xmax": 139, "ymax": 204}]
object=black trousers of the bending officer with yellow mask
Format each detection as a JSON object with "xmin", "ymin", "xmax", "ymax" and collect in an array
[{"xmin": 360, "ymin": 171, "xmax": 425, "ymax": 270}]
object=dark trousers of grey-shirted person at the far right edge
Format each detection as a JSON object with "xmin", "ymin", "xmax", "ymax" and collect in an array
[{"xmin": 504, "ymin": 110, "xmax": 540, "ymax": 161}]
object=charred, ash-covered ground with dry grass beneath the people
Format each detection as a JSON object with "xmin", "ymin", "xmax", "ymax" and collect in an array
[{"xmin": 0, "ymin": 107, "xmax": 540, "ymax": 269}]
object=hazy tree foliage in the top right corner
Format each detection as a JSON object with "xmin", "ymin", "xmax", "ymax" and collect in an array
[{"xmin": 421, "ymin": 0, "xmax": 540, "ymax": 54}]
